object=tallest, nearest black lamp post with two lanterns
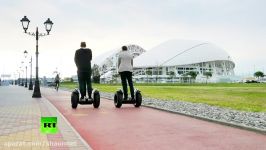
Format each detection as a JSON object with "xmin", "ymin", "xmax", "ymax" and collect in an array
[{"xmin": 20, "ymin": 16, "xmax": 53, "ymax": 98}]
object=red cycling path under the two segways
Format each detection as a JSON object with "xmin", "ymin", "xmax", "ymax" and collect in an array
[{"xmin": 42, "ymin": 88, "xmax": 266, "ymax": 150}]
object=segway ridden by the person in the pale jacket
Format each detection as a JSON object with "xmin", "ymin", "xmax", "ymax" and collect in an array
[{"xmin": 114, "ymin": 89, "xmax": 142, "ymax": 108}]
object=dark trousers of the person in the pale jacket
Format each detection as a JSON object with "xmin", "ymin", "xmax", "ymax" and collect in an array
[{"xmin": 119, "ymin": 71, "xmax": 134, "ymax": 99}]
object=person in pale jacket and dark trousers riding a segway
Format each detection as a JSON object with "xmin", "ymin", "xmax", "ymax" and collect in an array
[{"xmin": 118, "ymin": 46, "xmax": 134, "ymax": 100}]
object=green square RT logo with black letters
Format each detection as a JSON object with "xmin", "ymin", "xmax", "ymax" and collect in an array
[{"xmin": 40, "ymin": 117, "xmax": 58, "ymax": 134}]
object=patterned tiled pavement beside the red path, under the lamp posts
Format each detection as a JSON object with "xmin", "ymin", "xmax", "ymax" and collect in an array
[{"xmin": 0, "ymin": 86, "xmax": 90, "ymax": 150}]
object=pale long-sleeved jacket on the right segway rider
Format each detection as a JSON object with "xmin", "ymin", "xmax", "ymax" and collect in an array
[{"xmin": 118, "ymin": 51, "xmax": 133, "ymax": 72}]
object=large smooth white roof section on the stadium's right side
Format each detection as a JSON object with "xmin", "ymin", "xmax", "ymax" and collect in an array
[{"xmin": 134, "ymin": 40, "xmax": 232, "ymax": 68}]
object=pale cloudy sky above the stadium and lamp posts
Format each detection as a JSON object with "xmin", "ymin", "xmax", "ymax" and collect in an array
[{"xmin": 0, "ymin": 0, "xmax": 266, "ymax": 77}]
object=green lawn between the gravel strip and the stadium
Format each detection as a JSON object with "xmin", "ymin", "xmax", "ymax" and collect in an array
[{"xmin": 61, "ymin": 83, "xmax": 266, "ymax": 112}]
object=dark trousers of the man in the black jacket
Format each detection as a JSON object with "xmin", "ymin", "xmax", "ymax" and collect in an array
[{"xmin": 78, "ymin": 72, "xmax": 92, "ymax": 98}]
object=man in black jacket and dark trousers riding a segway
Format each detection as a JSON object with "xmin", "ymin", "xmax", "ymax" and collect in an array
[{"xmin": 74, "ymin": 42, "xmax": 92, "ymax": 99}]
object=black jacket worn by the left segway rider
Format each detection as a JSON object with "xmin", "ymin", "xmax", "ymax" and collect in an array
[{"xmin": 74, "ymin": 48, "xmax": 92, "ymax": 72}]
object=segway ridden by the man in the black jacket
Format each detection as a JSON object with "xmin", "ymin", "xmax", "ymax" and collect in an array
[{"xmin": 71, "ymin": 89, "xmax": 100, "ymax": 109}]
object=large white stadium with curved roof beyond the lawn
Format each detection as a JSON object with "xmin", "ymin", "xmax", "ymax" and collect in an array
[{"xmin": 93, "ymin": 40, "xmax": 235, "ymax": 83}]
